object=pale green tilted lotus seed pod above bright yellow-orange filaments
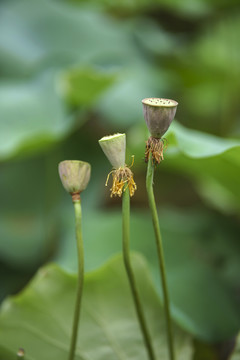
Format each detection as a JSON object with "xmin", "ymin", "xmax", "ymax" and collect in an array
[{"xmin": 98, "ymin": 134, "xmax": 126, "ymax": 169}]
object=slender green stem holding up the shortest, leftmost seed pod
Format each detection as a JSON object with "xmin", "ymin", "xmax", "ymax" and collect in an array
[{"xmin": 68, "ymin": 200, "xmax": 84, "ymax": 360}]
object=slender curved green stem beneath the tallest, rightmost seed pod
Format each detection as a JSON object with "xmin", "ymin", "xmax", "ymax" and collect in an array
[{"xmin": 146, "ymin": 156, "xmax": 175, "ymax": 360}]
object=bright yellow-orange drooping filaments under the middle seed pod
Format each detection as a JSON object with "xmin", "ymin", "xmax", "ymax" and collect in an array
[{"xmin": 105, "ymin": 165, "xmax": 137, "ymax": 197}]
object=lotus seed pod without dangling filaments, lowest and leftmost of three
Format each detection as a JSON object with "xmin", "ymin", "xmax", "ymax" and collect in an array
[{"xmin": 58, "ymin": 160, "xmax": 91, "ymax": 194}]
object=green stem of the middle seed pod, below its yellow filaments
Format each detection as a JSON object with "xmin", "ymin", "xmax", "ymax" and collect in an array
[{"xmin": 122, "ymin": 188, "xmax": 155, "ymax": 360}]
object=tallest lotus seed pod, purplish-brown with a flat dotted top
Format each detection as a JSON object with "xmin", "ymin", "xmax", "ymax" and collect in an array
[{"xmin": 142, "ymin": 98, "xmax": 178, "ymax": 138}]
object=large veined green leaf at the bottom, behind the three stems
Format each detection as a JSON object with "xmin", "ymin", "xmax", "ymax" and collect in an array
[{"xmin": 0, "ymin": 256, "xmax": 192, "ymax": 360}]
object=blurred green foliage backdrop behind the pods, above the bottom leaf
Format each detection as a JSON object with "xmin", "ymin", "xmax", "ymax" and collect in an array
[{"xmin": 0, "ymin": 0, "xmax": 240, "ymax": 358}]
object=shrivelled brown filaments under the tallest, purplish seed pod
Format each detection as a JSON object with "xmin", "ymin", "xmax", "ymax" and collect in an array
[{"xmin": 145, "ymin": 136, "xmax": 167, "ymax": 165}]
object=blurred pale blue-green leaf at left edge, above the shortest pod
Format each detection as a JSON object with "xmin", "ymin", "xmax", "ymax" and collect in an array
[{"xmin": 0, "ymin": 74, "xmax": 73, "ymax": 160}]
